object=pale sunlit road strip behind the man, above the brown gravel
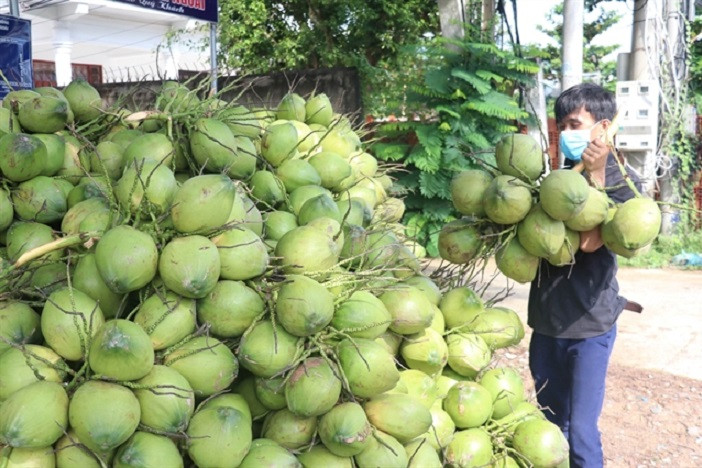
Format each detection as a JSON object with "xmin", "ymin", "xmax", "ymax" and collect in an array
[{"xmin": 482, "ymin": 268, "xmax": 702, "ymax": 380}]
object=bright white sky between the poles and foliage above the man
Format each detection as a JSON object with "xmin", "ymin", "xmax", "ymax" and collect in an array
[{"xmin": 506, "ymin": 0, "xmax": 634, "ymax": 59}]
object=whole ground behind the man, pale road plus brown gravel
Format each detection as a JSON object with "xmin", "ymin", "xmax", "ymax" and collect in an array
[{"xmin": 484, "ymin": 268, "xmax": 702, "ymax": 468}]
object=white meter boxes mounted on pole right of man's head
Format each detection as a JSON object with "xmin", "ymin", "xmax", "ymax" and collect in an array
[{"xmin": 615, "ymin": 80, "xmax": 659, "ymax": 151}]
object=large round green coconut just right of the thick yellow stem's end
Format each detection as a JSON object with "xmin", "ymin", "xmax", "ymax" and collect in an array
[{"xmin": 95, "ymin": 225, "xmax": 158, "ymax": 293}]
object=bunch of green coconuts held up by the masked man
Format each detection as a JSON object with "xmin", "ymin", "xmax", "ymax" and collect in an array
[{"xmin": 439, "ymin": 134, "xmax": 661, "ymax": 283}]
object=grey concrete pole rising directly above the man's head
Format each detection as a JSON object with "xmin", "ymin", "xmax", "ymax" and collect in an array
[{"xmin": 561, "ymin": 0, "xmax": 584, "ymax": 91}]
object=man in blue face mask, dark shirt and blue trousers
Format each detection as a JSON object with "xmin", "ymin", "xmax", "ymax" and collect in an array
[{"xmin": 528, "ymin": 83, "xmax": 638, "ymax": 468}]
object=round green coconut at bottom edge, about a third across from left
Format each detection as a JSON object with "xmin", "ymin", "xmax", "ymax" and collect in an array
[{"xmin": 187, "ymin": 407, "xmax": 252, "ymax": 468}]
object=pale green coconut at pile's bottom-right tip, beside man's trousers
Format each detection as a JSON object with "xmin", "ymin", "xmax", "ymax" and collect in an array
[{"xmin": 512, "ymin": 419, "xmax": 568, "ymax": 467}]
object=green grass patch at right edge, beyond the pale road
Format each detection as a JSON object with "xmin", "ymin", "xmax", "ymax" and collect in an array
[{"xmin": 618, "ymin": 230, "xmax": 702, "ymax": 270}]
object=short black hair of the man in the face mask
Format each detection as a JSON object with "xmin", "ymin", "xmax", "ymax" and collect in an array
[{"xmin": 554, "ymin": 83, "xmax": 617, "ymax": 122}]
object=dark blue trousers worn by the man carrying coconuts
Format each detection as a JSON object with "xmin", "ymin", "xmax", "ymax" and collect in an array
[{"xmin": 529, "ymin": 324, "xmax": 617, "ymax": 468}]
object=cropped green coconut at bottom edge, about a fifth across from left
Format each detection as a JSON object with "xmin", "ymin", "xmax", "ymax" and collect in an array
[{"xmin": 112, "ymin": 431, "xmax": 183, "ymax": 468}]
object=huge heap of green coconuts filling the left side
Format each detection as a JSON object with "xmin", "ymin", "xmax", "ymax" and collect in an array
[{"xmin": 0, "ymin": 80, "xmax": 572, "ymax": 468}]
